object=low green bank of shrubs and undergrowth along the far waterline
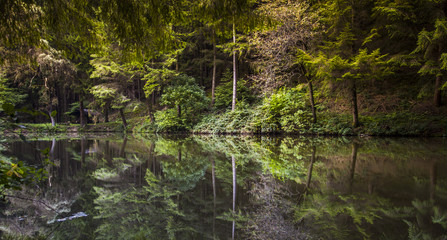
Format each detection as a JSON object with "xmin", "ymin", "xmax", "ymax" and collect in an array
[{"xmin": 7, "ymin": 104, "xmax": 447, "ymax": 137}]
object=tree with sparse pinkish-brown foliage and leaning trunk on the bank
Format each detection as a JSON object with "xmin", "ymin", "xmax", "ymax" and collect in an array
[{"xmin": 250, "ymin": 1, "xmax": 319, "ymax": 123}]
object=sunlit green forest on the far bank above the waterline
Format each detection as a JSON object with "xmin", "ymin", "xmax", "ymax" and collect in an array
[{"xmin": 0, "ymin": 0, "xmax": 447, "ymax": 136}]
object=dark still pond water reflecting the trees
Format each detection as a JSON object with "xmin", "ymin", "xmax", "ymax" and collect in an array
[{"xmin": 1, "ymin": 135, "xmax": 447, "ymax": 239}]
